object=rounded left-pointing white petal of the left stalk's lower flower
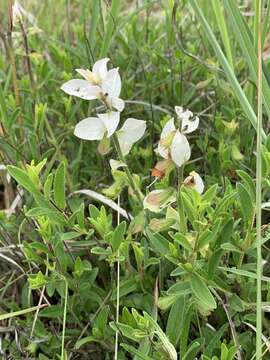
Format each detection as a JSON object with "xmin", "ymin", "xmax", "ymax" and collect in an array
[{"xmin": 74, "ymin": 117, "xmax": 106, "ymax": 140}]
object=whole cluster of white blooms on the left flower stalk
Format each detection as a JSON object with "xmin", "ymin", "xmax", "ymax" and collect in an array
[{"xmin": 61, "ymin": 58, "xmax": 146, "ymax": 155}]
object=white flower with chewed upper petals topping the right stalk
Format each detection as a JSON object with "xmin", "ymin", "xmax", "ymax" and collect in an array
[{"xmin": 157, "ymin": 106, "xmax": 199, "ymax": 167}]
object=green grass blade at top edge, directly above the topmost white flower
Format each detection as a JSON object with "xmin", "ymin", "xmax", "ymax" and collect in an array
[{"xmin": 100, "ymin": 0, "xmax": 120, "ymax": 58}]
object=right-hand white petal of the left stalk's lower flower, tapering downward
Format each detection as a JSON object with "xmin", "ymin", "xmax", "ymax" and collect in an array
[{"xmin": 117, "ymin": 118, "xmax": 146, "ymax": 156}]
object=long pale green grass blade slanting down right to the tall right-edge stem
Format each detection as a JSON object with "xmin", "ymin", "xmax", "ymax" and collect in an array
[{"xmin": 190, "ymin": 0, "xmax": 266, "ymax": 139}]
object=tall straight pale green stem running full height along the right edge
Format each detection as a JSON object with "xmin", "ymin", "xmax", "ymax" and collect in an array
[{"xmin": 256, "ymin": 0, "xmax": 262, "ymax": 360}]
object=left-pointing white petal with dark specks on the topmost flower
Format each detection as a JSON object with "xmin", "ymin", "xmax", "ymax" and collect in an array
[{"xmin": 61, "ymin": 79, "xmax": 101, "ymax": 100}]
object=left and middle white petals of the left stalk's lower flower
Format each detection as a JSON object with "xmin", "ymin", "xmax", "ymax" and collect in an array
[{"xmin": 74, "ymin": 111, "xmax": 120, "ymax": 140}]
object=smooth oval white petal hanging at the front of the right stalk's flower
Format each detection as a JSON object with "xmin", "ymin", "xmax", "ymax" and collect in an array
[{"xmin": 170, "ymin": 131, "xmax": 191, "ymax": 167}]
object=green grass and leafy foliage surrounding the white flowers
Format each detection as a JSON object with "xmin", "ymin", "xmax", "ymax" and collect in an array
[{"xmin": 0, "ymin": 0, "xmax": 270, "ymax": 360}]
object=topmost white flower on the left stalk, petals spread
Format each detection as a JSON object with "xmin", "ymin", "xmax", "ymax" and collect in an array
[{"xmin": 61, "ymin": 58, "xmax": 125, "ymax": 111}]
